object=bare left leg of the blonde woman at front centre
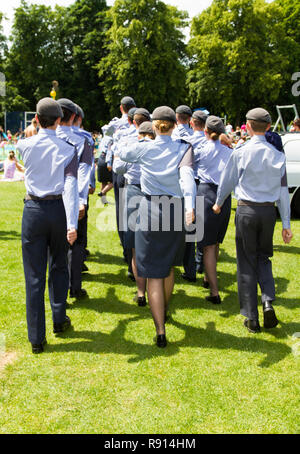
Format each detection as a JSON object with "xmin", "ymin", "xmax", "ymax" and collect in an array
[{"xmin": 148, "ymin": 278, "xmax": 165, "ymax": 335}]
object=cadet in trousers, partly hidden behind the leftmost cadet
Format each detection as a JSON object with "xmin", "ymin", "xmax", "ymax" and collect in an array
[{"xmin": 56, "ymin": 98, "xmax": 93, "ymax": 299}]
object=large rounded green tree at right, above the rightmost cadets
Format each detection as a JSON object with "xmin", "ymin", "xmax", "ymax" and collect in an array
[{"xmin": 188, "ymin": 0, "xmax": 287, "ymax": 124}]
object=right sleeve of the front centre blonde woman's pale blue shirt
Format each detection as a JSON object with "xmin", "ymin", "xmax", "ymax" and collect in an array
[{"xmin": 179, "ymin": 147, "xmax": 196, "ymax": 211}]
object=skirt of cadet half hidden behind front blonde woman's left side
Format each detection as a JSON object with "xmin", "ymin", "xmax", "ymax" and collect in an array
[{"xmin": 123, "ymin": 184, "xmax": 143, "ymax": 249}]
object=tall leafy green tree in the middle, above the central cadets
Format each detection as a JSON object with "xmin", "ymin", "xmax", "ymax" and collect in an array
[{"xmin": 98, "ymin": 0, "xmax": 187, "ymax": 115}]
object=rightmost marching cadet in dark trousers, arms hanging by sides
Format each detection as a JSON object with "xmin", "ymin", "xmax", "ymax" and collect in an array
[{"xmin": 213, "ymin": 107, "xmax": 293, "ymax": 333}]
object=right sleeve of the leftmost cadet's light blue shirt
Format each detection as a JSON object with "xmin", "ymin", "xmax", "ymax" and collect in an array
[{"xmin": 63, "ymin": 152, "xmax": 79, "ymax": 229}]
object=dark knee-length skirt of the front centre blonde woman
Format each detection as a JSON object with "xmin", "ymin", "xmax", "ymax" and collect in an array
[{"xmin": 135, "ymin": 196, "xmax": 185, "ymax": 279}]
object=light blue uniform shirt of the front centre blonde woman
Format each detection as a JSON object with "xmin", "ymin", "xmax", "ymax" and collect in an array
[{"xmin": 120, "ymin": 135, "xmax": 196, "ymax": 210}]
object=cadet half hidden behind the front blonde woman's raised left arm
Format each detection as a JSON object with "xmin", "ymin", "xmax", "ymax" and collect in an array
[{"xmin": 113, "ymin": 108, "xmax": 153, "ymax": 306}]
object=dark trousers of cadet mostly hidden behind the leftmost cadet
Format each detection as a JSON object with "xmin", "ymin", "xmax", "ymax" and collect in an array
[{"xmin": 68, "ymin": 214, "xmax": 87, "ymax": 292}]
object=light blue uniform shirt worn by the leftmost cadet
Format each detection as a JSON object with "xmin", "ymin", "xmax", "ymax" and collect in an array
[{"xmin": 17, "ymin": 128, "xmax": 79, "ymax": 229}]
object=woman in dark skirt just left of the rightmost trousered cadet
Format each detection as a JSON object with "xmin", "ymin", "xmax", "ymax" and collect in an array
[{"xmin": 198, "ymin": 115, "xmax": 232, "ymax": 304}]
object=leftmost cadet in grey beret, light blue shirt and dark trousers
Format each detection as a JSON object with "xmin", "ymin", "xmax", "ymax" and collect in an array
[{"xmin": 17, "ymin": 98, "xmax": 78, "ymax": 353}]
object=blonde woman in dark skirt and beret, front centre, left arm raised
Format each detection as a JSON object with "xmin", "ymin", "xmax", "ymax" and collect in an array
[{"xmin": 120, "ymin": 106, "xmax": 196, "ymax": 347}]
